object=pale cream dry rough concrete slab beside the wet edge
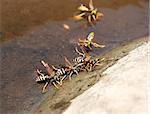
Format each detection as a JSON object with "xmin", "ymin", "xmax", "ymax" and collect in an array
[{"xmin": 63, "ymin": 42, "xmax": 150, "ymax": 114}]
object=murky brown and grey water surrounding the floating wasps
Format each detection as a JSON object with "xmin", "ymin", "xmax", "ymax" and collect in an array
[{"xmin": 0, "ymin": 0, "xmax": 149, "ymax": 114}]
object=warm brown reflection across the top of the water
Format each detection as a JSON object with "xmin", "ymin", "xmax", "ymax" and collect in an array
[{"xmin": 1, "ymin": 0, "xmax": 148, "ymax": 41}]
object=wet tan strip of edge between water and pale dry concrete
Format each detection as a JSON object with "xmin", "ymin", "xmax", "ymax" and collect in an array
[{"xmin": 31, "ymin": 36, "xmax": 150, "ymax": 114}]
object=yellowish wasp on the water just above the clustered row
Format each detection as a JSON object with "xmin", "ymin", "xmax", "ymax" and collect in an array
[{"xmin": 78, "ymin": 32, "xmax": 105, "ymax": 51}]
